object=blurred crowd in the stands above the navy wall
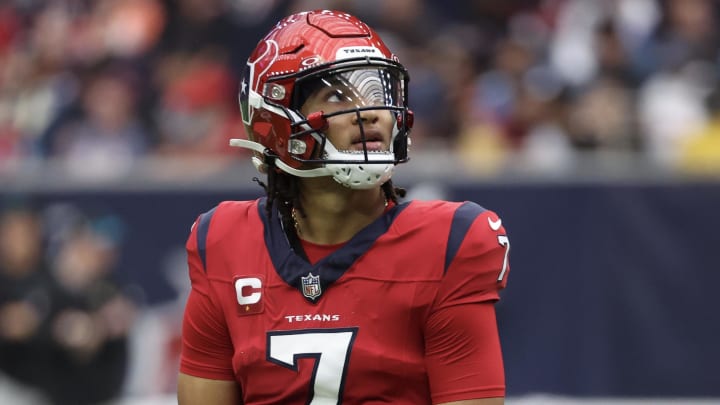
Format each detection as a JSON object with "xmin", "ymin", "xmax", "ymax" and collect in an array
[{"xmin": 0, "ymin": 0, "xmax": 720, "ymax": 178}]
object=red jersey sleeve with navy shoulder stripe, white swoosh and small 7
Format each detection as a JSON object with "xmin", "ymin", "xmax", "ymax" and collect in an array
[{"xmin": 425, "ymin": 203, "xmax": 509, "ymax": 403}]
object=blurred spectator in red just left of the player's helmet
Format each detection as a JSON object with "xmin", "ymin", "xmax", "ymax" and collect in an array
[{"xmin": 146, "ymin": 50, "xmax": 245, "ymax": 179}]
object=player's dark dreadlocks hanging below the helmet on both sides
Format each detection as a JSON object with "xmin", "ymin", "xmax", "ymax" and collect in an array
[{"xmin": 253, "ymin": 167, "xmax": 407, "ymax": 234}]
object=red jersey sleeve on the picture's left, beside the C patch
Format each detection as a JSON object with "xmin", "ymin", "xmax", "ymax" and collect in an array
[{"xmin": 180, "ymin": 213, "xmax": 235, "ymax": 380}]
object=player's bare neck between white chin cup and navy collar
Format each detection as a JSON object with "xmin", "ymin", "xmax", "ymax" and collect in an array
[{"xmin": 295, "ymin": 179, "xmax": 386, "ymax": 244}]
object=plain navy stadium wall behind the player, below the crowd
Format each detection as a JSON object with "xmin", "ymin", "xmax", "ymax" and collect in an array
[{"xmin": 0, "ymin": 182, "xmax": 720, "ymax": 402}]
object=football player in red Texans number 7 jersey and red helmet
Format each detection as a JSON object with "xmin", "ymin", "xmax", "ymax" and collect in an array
[{"xmin": 178, "ymin": 10, "xmax": 510, "ymax": 405}]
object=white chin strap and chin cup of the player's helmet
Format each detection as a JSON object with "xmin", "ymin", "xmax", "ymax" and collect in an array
[{"xmin": 230, "ymin": 139, "xmax": 395, "ymax": 190}]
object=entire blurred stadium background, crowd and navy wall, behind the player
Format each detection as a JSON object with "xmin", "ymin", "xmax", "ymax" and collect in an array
[{"xmin": 0, "ymin": 0, "xmax": 720, "ymax": 405}]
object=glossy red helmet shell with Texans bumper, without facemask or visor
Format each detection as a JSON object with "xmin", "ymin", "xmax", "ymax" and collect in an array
[{"xmin": 239, "ymin": 10, "xmax": 397, "ymax": 168}]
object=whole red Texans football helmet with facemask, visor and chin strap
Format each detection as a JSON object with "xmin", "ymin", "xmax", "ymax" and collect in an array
[{"xmin": 230, "ymin": 10, "xmax": 413, "ymax": 189}]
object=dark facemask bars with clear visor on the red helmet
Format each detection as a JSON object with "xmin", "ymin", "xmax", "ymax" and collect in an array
[{"xmin": 289, "ymin": 58, "xmax": 412, "ymax": 189}]
